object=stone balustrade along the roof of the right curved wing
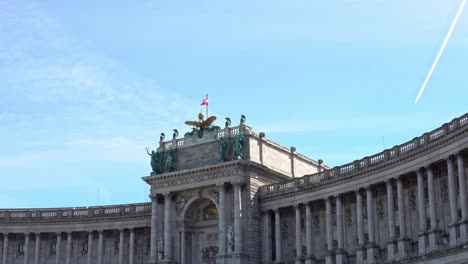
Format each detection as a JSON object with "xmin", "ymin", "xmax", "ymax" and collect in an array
[{"xmin": 260, "ymin": 113, "xmax": 468, "ymax": 197}]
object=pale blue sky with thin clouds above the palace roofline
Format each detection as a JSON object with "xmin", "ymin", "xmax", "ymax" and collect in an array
[{"xmin": 0, "ymin": 0, "xmax": 468, "ymax": 208}]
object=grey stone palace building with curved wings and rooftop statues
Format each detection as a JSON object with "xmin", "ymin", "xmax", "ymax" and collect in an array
[{"xmin": 0, "ymin": 113, "xmax": 468, "ymax": 264}]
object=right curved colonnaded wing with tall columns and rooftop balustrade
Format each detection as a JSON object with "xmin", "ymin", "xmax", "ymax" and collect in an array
[{"xmin": 260, "ymin": 114, "xmax": 468, "ymax": 263}]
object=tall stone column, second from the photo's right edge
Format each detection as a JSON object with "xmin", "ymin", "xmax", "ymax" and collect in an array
[{"xmin": 447, "ymin": 156, "xmax": 458, "ymax": 246}]
